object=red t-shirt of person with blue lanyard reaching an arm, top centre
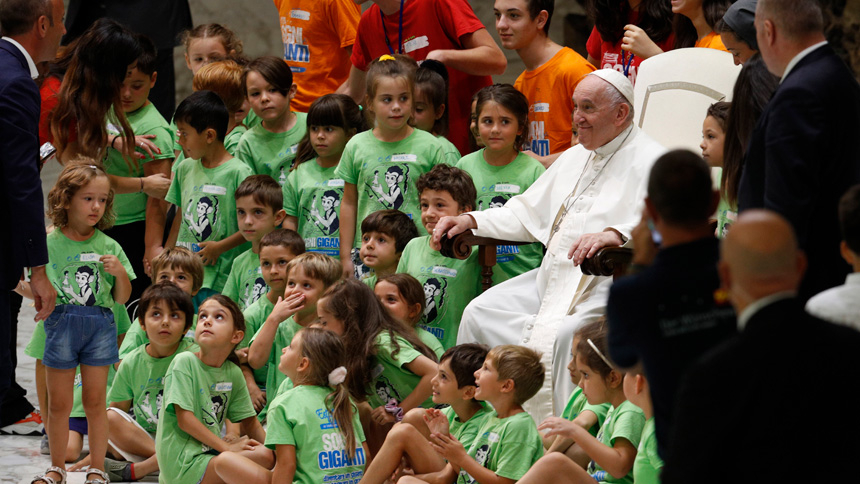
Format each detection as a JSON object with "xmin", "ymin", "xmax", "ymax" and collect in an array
[{"xmin": 351, "ymin": 0, "xmax": 493, "ymax": 153}]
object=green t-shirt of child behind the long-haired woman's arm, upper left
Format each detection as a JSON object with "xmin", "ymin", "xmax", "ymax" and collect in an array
[{"xmin": 104, "ymin": 103, "xmax": 173, "ymax": 225}]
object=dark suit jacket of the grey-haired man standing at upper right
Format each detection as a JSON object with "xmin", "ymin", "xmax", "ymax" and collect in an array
[{"xmin": 738, "ymin": 46, "xmax": 860, "ymax": 299}]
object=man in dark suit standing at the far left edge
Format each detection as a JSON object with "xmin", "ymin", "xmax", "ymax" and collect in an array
[{"xmin": 0, "ymin": 0, "xmax": 65, "ymax": 432}]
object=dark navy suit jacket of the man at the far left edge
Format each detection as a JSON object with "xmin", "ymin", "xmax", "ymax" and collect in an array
[{"xmin": 0, "ymin": 40, "xmax": 48, "ymax": 290}]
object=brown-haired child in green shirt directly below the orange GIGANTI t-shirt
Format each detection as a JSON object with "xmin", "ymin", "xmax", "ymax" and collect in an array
[{"xmin": 236, "ymin": 56, "xmax": 307, "ymax": 186}]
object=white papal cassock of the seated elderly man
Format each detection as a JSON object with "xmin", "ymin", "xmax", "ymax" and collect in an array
[{"xmin": 457, "ymin": 125, "xmax": 666, "ymax": 421}]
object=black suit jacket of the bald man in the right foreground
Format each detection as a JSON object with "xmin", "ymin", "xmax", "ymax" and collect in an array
[{"xmin": 662, "ymin": 299, "xmax": 860, "ymax": 484}]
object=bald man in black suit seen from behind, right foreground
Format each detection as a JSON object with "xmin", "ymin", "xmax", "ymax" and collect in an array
[{"xmin": 662, "ymin": 210, "xmax": 860, "ymax": 484}]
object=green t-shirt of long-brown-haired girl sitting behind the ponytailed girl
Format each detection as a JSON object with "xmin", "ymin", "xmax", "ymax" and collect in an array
[{"xmin": 366, "ymin": 331, "xmax": 433, "ymax": 408}]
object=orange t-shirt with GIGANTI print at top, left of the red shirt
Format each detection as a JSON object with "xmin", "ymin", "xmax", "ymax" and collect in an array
[{"xmin": 274, "ymin": 0, "xmax": 361, "ymax": 113}]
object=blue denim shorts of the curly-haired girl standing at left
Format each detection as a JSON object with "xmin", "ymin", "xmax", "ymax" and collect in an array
[{"xmin": 42, "ymin": 304, "xmax": 119, "ymax": 370}]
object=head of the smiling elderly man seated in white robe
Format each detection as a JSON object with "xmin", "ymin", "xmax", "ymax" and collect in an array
[{"xmin": 573, "ymin": 76, "xmax": 621, "ymax": 150}]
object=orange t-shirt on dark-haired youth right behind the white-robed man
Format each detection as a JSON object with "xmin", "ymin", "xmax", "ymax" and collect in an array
[{"xmin": 514, "ymin": 47, "xmax": 594, "ymax": 156}]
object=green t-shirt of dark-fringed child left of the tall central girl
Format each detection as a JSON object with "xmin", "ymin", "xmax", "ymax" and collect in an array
[{"xmin": 284, "ymin": 158, "xmax": 343, "ymax": 259}]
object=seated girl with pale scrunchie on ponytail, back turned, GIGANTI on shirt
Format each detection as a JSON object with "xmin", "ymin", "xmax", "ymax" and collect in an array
[{"xmin": 266, "ymin": 328, "xmax": 368, "ymax": 484}]
